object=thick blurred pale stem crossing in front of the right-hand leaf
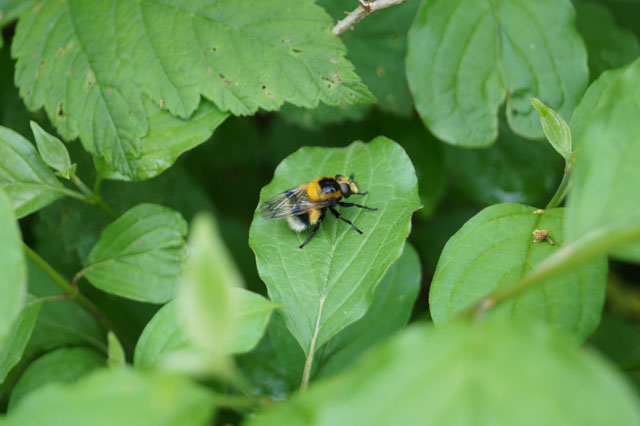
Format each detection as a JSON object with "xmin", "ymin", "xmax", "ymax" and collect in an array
[{"xmin": 460, "ymin": 210, "xmax": 640, "ymax": 318}]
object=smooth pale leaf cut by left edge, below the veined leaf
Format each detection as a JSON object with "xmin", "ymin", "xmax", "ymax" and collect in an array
[{"xmin": 0, "ymin": 189, "xmax": 27, "ymax": 345}]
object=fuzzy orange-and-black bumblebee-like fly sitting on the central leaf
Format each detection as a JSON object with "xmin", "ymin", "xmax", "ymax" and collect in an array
[{"xmin": 260, "ymin": 175, "xmax": 378, "ymax": 248}]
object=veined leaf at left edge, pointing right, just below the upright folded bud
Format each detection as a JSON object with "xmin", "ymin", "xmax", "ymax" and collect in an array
[{"xmin": 0, "ymin": 126, "xmax": 69, "ymax": 218}]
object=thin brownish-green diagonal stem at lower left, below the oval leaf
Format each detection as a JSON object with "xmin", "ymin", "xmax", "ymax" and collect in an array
[{"xmin": 22, "ymin": 242, "xmax": 133, "ymax": 350}]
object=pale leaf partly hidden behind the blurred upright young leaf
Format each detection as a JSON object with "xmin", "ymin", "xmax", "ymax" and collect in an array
[{"xmin": 133, "ymin": 288, "xmax": 275, "ymax": 368}]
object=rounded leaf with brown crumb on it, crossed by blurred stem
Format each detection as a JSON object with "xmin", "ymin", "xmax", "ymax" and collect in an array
[{"xmin": 429, "ymin": 204, "xmax": 607, "ymax": 340}]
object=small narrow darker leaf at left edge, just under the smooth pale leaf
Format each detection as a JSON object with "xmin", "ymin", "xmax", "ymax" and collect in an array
[{"xmin": 0, "ymin": 301, "xmax": 42, "ymax": 384}]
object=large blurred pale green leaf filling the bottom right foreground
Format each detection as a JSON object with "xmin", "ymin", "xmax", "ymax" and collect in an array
[{"xmin": 247, "ymin": 321, "xmax": 640, "ymax": 426}]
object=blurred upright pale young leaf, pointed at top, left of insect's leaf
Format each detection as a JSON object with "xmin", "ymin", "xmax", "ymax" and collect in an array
[{"xmin": 176, "ymin": 215, "xmax": 244, "ymax": 359}]
